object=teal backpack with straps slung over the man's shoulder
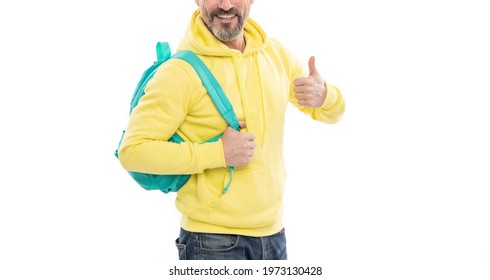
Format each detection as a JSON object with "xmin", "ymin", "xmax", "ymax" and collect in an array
[{"xmin": 115, "ymin": 42, "xmax": 240, "ymax": 193}]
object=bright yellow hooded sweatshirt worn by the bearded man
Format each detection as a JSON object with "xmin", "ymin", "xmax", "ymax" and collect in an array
[{"xmin": 119, "ymin": 10, "xmax": 344, "ymax": 236}]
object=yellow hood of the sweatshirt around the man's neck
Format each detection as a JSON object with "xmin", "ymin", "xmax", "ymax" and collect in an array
[{"xmin": 178, "ymin": 9, "xmax": 268, "ymax": 56}]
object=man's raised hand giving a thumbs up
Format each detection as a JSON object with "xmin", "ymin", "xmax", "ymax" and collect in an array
[{"xmin": 294, "ymin": 56, "xmax": 327, "ymax": 108}]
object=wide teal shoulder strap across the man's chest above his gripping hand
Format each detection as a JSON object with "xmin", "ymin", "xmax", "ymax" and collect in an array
[{"xmin": 172, "ymin": 50, "xmax": 240, "ymax": 130}]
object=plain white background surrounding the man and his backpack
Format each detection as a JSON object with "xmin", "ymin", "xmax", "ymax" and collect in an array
[{"xmin": 0, "ymin": 0, "xmax": 490, "ymax": 280}]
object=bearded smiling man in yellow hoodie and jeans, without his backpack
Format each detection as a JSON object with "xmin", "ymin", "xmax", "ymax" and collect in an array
[{"xmin": 119, "ymin": 0, "xmax": 344, "ymax": 259}]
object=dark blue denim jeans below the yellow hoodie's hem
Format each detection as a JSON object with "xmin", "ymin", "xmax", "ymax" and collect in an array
[{"xmin": 175, "ymin": 229, "xmax": 287, "ymax": 260}]
